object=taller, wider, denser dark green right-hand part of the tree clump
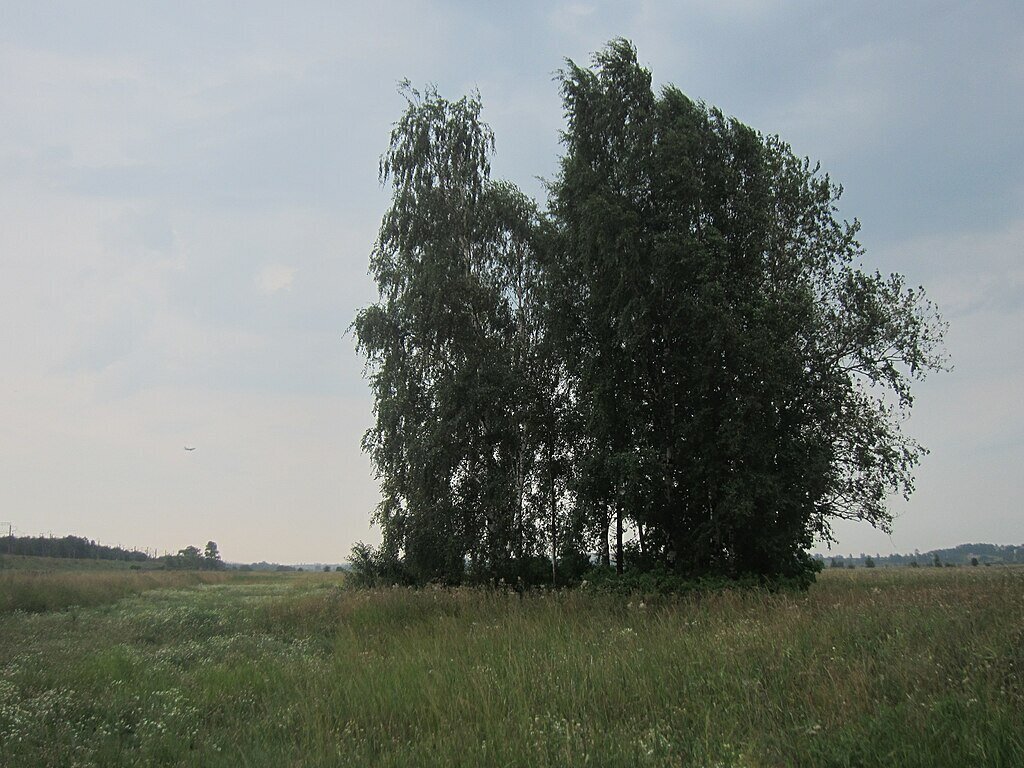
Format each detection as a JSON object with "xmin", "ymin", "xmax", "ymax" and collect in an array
[{"xmin": 552, "ymin": 40, "xmax": 943, "ymax": 577}]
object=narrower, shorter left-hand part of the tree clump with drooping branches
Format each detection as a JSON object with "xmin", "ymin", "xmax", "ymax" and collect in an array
[{"xmin": 353, "ymin": 86, "xmax": 560, "ymax": 584}]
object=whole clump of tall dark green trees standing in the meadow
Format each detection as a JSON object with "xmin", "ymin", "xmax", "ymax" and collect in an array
[{"xmin": 353, "ymin": 40, "xmax": 944, "ymax": 583}]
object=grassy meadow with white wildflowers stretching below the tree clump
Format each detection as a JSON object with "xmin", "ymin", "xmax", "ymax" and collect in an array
[{"xmin": 0, "ymin": 567, "xmax": 1024, "ymax": 768}]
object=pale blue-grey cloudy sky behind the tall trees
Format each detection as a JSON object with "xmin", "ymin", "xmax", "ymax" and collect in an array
[{"xmin": 0, "ymin": 0, "xmax": 1024, "ymax": 562}]
